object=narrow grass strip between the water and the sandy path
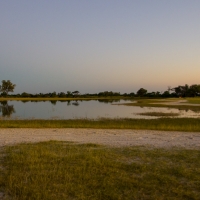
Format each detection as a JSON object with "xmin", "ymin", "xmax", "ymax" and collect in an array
[{"xmin": 0, "ymin": 118, "xmax": 200, "ymax": 131}]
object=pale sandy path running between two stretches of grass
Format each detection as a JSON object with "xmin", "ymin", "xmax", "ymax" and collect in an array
[{"xmin": 0, "ymin": 129, "xmax": 200, "ymax": 149}]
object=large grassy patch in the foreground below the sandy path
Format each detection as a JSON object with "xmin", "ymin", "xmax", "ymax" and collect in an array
[{"xmin": 0, "ymin": 141, "xmax": 200, "ymax": 200}]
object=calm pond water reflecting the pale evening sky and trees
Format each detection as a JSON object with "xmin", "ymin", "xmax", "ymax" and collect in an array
[{"xmin": 0, "ymin": 100, "xmax": 200, "ymax": 119}]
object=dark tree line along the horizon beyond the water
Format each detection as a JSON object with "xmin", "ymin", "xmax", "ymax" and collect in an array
[{"xmin": 0, "ymin": 80, "xmax": 200, "ymax": 98}]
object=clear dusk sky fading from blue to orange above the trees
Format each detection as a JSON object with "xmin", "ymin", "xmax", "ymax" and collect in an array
[{"xmin": 0, "ymin": 0, "xmax": 200, "ymax": 93}]
